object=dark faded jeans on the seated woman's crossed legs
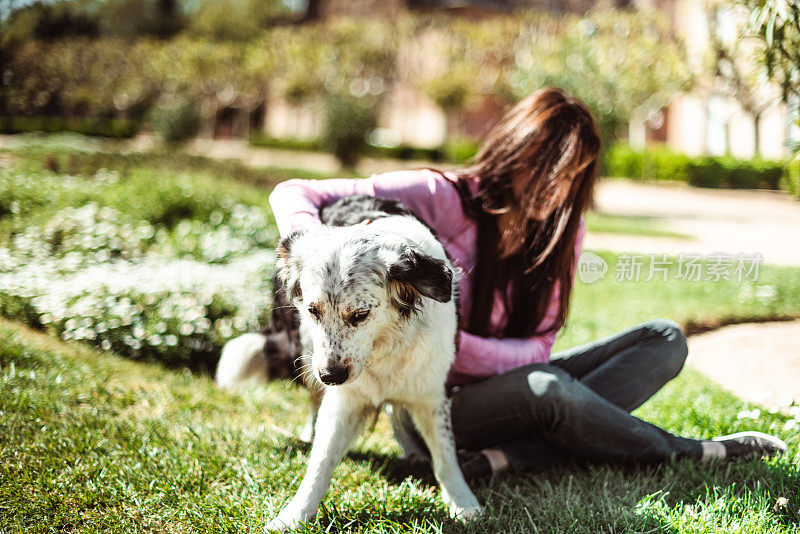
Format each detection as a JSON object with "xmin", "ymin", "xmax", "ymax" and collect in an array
[{"xmin": 452, "ymin": 320, "xmax": 702, "ymax": 472}]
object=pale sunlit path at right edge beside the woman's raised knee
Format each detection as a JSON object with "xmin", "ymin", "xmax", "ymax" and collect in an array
[{"xmin": 687, "ymin": 320, "xmax": 800, "ymax": 412}]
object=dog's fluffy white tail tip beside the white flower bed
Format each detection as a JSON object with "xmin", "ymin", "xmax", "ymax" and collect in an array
[{"xmin": 214, "ymin": 334, "xmax": 270, "ymax": 389}]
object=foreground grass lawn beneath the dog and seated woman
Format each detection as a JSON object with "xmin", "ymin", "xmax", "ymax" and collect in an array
[{"xmin": 0, "ymin": 321, "xmax": 800, "ymax": 533}]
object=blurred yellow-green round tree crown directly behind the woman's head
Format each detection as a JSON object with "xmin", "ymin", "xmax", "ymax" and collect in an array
[{"xmin": 511, "ymin": 9, "xmax": 692, "ymax": 147}]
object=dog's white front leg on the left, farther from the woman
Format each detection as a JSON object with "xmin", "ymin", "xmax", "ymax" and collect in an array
[{"xmin": 267, "ymin": 388, "xmax": 367, "ymax": 530}]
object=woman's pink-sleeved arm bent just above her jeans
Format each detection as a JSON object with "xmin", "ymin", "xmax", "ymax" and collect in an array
[{"xmin": 451, "ymin": 220, "xmax": 586, "ymax": 383}]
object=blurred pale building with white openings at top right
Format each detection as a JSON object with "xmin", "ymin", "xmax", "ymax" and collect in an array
[{"xmin": 630, "ymin": 0, "xmax": 798, "ymax": 159}]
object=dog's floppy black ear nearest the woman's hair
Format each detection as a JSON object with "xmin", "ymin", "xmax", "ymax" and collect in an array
[{"xmin": 389, "ymin": 249, "xmax": 453, "ymax": 317}]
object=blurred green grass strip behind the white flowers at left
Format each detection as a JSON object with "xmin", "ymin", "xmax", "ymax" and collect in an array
[{"xmin": 0, "ymin": 144, "xmax": 328, "ymax": 240}]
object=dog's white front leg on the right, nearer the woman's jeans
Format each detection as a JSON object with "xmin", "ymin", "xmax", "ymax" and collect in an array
[{"xmin": 409, "ymin": 398, "xmax": 482, "ymax": 519}]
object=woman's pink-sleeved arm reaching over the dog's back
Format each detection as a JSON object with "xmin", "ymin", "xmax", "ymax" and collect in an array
[{"xmin": 269, "ymin": 170, "xmax": 458, "ymax": 236}]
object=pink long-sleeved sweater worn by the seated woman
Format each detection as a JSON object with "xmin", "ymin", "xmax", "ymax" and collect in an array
[{"xmin": 269, "ymin": 170, "xmax": 585, "ymax": 385}]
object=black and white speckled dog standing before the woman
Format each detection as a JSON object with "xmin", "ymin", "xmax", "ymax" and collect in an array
[{"xmin": 217, "ymin": 197, "xmax": 481, "ymax": 530}]
